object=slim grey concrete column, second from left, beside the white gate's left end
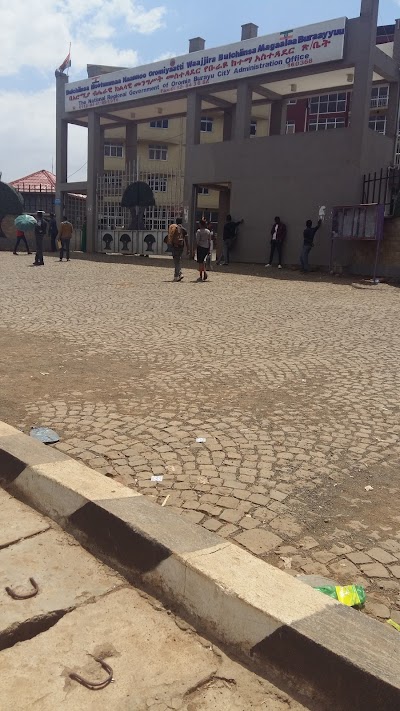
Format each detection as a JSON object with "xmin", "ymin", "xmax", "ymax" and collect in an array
[{"xmin": 86, "ymin": 111, "xmax": 101, "ymax": 254}]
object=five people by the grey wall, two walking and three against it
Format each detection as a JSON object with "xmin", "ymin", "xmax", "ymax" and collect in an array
[{"xmin": 167, "ymin": 215, "xmax": 322, "ymax": 281}]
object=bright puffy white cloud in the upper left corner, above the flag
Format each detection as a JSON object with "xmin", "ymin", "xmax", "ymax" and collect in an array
[{"xmin": 0, "ymin": 0, "xmax": 166, "ymax": 76}]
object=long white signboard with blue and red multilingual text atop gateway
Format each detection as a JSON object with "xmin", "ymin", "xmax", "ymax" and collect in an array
[{"xmin": 65, "ymin": 17, "xmax": 346, "ymax": 112}]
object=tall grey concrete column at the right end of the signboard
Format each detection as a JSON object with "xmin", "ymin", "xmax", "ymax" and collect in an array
[{"xmin": 351, "ymin": 0, "xmax": 379, "ymax": 154}]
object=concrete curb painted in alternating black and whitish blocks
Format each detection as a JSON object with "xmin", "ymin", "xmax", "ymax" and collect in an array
[{"xmin": 0, "ymin": 423, "xmax": 400, "ymax": 711}]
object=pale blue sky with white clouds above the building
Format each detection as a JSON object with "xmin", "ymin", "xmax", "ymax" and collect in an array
[{"xmin": 0, "ymin": 0, "xmax": 400, "ymax": 182}]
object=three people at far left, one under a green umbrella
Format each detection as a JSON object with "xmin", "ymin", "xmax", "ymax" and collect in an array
[{"xmin": 13, "ymin": 210, "xmax": 73, "ymax": 267}]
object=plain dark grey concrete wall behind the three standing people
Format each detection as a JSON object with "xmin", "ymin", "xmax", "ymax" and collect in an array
[{"xmin": 186, "ymin": 128, "xmax": 393, "ymax": 266}]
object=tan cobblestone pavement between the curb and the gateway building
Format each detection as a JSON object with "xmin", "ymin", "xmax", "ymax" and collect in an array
[{"xmin": 0, "ymin": 254, "xmax": 400, "ymax": 619}]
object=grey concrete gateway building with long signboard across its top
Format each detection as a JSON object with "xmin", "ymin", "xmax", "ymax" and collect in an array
[{"xmin": 56, "ymin": 0, "xmax": 400, "ymax": 266}]
